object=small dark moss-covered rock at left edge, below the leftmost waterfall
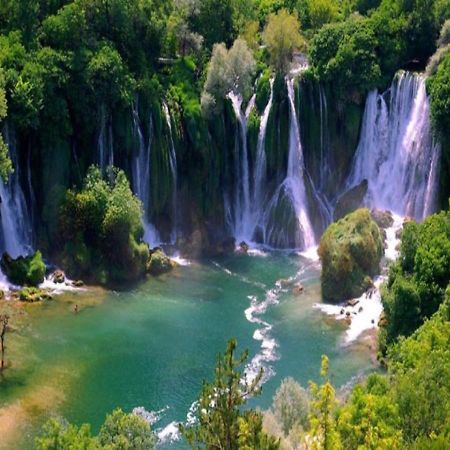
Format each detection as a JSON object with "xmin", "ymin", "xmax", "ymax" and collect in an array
[{"xmin": 0, "ymin": 251, "xmax": 45, "ymax": 286}]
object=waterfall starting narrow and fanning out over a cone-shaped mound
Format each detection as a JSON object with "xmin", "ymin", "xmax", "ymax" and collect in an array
[{"xmin": 263, "ymin": 78, "xmax": 315, "ymax": 249}]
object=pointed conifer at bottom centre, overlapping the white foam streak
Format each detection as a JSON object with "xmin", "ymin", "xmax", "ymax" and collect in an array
[{"xmin": 180, "ymin": 339, "xmax": 279, "ymax": 450}]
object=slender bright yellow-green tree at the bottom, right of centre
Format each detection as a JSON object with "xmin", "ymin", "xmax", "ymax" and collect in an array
[{"xmin": 309, "ymin": 355, "xmax": 342, "ymax": 450}]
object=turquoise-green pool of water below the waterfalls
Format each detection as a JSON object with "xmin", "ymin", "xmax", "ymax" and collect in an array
[{"xmin": 0, "ymin": 254, "xmax": 371, "ymax": 448}]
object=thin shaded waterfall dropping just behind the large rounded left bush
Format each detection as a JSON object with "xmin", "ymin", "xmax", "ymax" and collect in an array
[{"xmin": 131, "ymin": 101, "xmax": 160, "ymax": 247}]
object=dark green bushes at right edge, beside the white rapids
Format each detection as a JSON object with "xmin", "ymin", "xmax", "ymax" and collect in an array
[{"xmin": 381, "ymin": 212, "xmax": 450, "ymax": 349}]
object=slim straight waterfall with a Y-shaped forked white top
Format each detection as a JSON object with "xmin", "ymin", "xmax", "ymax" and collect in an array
[{"xmin": 228, "ymin": 92, "xmax": 256, "ymax": 240}]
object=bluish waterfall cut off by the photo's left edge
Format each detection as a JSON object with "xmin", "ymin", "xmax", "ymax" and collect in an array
[{"xmin": 0, "ymin": 125, "xmax": 33, "ymax": 258}]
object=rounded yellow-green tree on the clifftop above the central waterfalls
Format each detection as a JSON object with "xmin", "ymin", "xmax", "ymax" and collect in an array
[{"xmin": 263, "ymin": 9, "xmax": 305, "ymax": 75}]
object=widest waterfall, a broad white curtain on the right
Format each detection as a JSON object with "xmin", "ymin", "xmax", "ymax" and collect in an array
[{"xmin": 347, "ymin": 72, "xmax": 440, "ymax": 220}]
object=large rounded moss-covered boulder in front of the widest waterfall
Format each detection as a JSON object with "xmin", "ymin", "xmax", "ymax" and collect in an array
[{"xmin": 319, "ymin": 209, "xmax": 383, "ymax": 302}]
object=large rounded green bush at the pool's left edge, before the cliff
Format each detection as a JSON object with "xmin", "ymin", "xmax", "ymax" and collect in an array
[{"xmin": 60, "ymin": 167, "xmax": 148, "ymax": 283}]
